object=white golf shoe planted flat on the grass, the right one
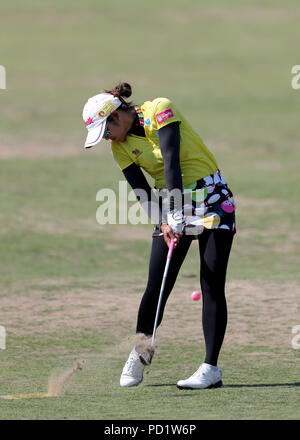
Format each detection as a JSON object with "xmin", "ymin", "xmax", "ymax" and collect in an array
[{"xmin": 177, "ymin": 363, "xmax": 223, "ymax": 390}]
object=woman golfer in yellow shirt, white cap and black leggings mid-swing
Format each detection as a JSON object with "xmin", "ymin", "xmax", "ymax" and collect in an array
[{"xmin": 83, "ymin": 83, "xmax": 236, "ymax": 389}]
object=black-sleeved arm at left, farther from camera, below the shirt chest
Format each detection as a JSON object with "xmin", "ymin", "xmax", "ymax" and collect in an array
[{"xmin": 123, "ymin": 163, "xmax": 161, "ymax": 223}]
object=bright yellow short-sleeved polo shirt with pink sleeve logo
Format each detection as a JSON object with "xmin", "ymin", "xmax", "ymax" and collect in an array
[{"xmin": 111, "ymin": 98, "xmax": 218, "ymax": 189}]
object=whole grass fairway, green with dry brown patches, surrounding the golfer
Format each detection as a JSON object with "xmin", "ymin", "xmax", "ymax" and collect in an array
[{"xmin": 0, "ymin": 0, "xmax": 300, "ymax": 420}]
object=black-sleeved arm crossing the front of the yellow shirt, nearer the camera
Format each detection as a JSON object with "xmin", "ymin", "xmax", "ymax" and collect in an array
[{"xmin": 158, "ymin": 122, "xmax": 183, "ymax": 210}]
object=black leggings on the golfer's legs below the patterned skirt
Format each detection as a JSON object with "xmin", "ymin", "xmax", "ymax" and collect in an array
[{"xmin": 136, "ymin": 229, "xmax": 233, "ymax": 365}]
